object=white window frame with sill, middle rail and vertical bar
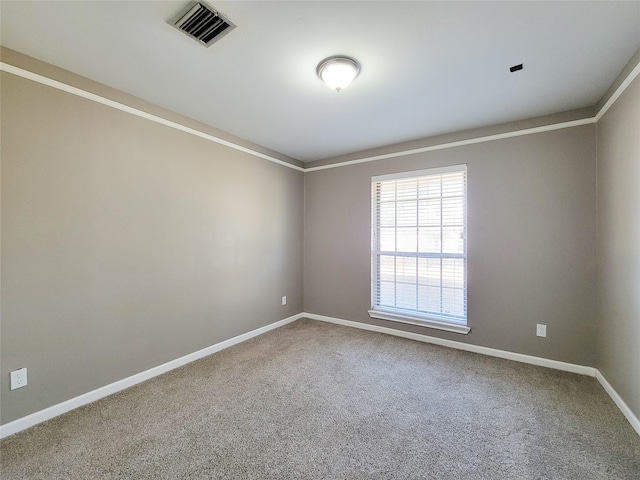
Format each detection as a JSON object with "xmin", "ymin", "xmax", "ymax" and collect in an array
[{"xmin": 369, "ymin": 165, "xmax": 471, "ymax": 334}]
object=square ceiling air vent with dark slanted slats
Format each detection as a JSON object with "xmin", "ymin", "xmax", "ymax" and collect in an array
[{"xmin": 172, "ymin": 2, "xmax": 236, "ymax": 47}]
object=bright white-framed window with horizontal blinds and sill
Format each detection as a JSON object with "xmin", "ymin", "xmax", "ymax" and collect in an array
[{"xmin": 369, "ymin": 165, "xmax": 470, "ymax": 333}]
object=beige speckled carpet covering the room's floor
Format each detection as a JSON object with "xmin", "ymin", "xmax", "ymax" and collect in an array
[{"xmin": 0, "ymin": 320, "xmax": 640, "ymax": 480}]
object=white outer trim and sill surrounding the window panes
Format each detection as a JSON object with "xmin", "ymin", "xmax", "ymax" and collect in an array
[{"xmin": 368, "ymin": 164, "xmax": 471, "ymax": 335}]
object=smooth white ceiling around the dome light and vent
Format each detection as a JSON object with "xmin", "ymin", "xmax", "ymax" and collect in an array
[{"xmin": 0, "ymin": 0, "xmax": 640, "ymax": 161}]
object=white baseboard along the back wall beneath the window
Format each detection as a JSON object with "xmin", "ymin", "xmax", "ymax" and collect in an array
[{"xmin": 303, "ymin": 313, "xmax": 596, "ymax": 377}]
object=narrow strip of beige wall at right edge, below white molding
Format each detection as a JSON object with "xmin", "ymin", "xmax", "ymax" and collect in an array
[{"xmin": 596, "ymin": 71, "xmax": 640, "ymax": 418}]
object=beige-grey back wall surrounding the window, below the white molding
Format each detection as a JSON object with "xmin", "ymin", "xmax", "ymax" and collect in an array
[{"xmin": 304, "ymin": 125, "xmax": 596, "ymax": 366}]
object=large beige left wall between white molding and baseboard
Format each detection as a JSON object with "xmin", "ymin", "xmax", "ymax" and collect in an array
[{"xmin": 0, "ymin": 57, "xmax": 304, "ymax": 424}]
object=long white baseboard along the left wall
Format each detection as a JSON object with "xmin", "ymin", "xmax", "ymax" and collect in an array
[{"xmin": 0, "ymin": 313, "xmax": 304, "ymax": 438}]
